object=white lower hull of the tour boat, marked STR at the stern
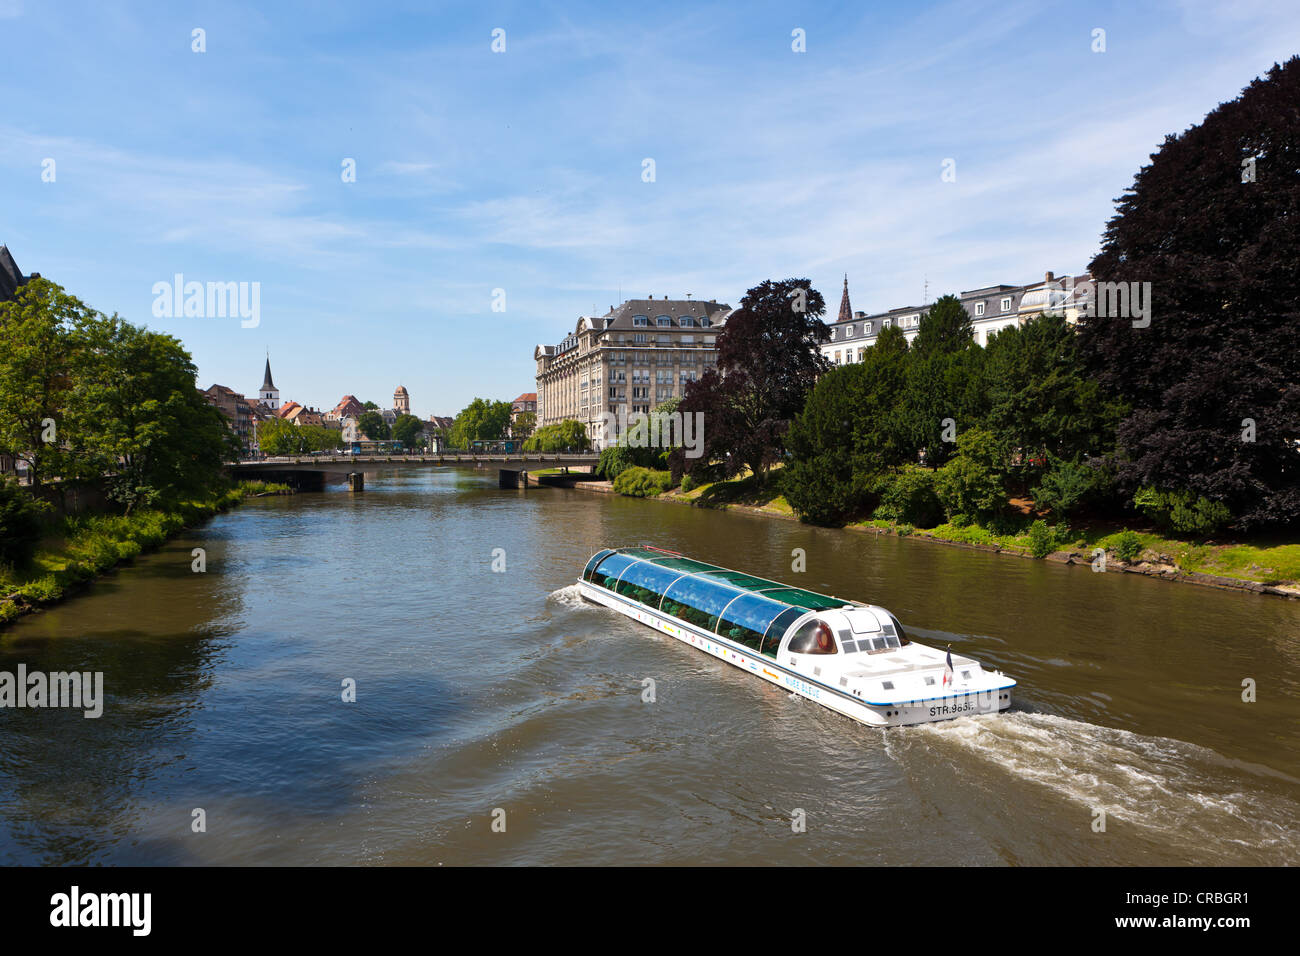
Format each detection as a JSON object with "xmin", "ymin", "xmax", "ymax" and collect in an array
[{"xmin": 577, "ymin": 580, "xmax": 1014, "ymax": 727}]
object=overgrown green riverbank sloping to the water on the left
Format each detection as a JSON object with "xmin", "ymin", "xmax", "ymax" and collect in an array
[{"xmin": 0, "ymin": 481, "xmax": 291, "ymax": 628}]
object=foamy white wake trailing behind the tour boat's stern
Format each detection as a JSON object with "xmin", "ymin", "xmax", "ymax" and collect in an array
[{"xmin": 885, "ymin": 711, "xmax": 1300, "ymax": 864}]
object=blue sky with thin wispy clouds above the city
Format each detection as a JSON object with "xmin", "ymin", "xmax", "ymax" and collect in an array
[{"xmin": 0, "ymin": 0, "xmax": 1300, "ymax": 416}]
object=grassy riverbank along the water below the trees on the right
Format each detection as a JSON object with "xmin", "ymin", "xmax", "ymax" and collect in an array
[{"xmin": 554, "ymin": 468, "xmax": 1300, "ymax": 600}]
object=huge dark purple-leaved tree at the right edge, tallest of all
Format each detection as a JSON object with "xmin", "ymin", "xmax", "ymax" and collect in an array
[{"xmin": 1080, "ymin": 57, "xmax": 1300, "ymax": 528}]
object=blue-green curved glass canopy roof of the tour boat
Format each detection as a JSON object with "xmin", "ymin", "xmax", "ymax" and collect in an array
[{"xmin": 582, "ymin": 548, "xmax": 867, "ymax": 657}]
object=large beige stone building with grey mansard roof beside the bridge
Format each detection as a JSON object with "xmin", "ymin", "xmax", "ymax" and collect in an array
[{"xmin": 533, "ymin": 297, "xmax": 732, "ymax": 447}]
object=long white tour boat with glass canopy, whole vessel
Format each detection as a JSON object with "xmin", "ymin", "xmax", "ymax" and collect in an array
[{"xmin": 579, "ymin": 548, "xmax": 1015, "ymax": 727}]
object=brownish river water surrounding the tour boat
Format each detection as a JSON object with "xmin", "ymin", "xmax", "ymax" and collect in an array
[{"xmin": 0, "ymin": 470, "xmax": 1300, "ymax": 865}]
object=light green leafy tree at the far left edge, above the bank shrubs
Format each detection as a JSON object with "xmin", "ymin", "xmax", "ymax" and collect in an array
[{"xmin": 0, "ymin": 278, "xmax": 95, "ymax": 486}]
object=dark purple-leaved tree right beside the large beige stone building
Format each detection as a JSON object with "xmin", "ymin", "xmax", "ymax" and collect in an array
[{"xmin": 670, "ymin": 278, "xmax": 831, "ymax": 479}]
